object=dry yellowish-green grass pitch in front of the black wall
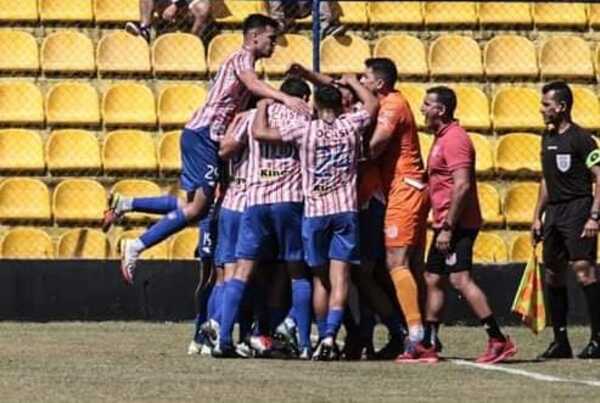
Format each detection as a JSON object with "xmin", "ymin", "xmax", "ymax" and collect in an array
[{"xmin": 0, "ymin": 322, "xmax": 600, "ymax": 402}]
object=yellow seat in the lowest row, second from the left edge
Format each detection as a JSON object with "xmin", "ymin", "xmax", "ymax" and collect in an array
[{"xmin": 56, "ymin": 228, "xmax": 112, "ymax": 259}]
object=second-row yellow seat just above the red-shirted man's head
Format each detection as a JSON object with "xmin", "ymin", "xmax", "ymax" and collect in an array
[{"xmin": 429, "ymin": 35, "xmax": 483, "ymax": 77}]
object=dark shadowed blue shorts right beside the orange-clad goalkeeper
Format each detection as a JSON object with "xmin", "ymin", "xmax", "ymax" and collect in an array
[{"xmin": 358, "ymin": 198, "xmax": 385, "ymax": 262}]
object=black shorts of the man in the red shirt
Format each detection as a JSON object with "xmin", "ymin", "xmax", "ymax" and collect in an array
[{"xmin": 425, "ymin": 228, "xmax": 479, "ymax": 275}]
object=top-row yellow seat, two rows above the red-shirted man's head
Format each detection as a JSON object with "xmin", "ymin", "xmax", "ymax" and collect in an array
[{"xmin": 425, "ymin": 1, "xmax": 477, "ymax": 26}]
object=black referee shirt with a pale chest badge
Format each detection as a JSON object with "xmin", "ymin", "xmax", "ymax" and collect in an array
[{"xmin": 542, "ymin": 124, "xmax": 598, "ymax": 204}]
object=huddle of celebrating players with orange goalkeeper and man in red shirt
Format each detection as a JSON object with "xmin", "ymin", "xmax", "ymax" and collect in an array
[{"xmin": 104, "ymin": 14, "xmax": 517, "ymax": 363}]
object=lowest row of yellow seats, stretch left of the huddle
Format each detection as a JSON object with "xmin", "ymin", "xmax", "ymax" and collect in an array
[{"xmin": 0, "ymin": 227, "xmax": 199, "ymax": 259}]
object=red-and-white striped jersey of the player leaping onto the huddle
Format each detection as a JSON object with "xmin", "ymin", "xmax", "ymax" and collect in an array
[{"xmin": 185, "ymin": 48, "xmax": 256, "ymax": 141}]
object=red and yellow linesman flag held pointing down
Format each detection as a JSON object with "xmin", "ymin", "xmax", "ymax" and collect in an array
[{"xmin": 512, "ymin": 250, "xmax": 546, "ymax": 334}]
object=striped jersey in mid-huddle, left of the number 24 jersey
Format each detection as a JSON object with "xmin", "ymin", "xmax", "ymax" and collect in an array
[{"xmin": 238, "ymin": 103, "xmax": 310, "ymax": 206}]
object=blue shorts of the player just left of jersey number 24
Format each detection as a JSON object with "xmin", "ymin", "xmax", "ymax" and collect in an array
[{"xmin": 235, "ymin": 203, "xmax": 304, "ymax": 262}]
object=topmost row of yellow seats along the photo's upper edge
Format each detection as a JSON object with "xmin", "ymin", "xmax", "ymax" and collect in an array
[{"xmin": 0, "ymin": 0, "xmax": 600, "ymax": 27}]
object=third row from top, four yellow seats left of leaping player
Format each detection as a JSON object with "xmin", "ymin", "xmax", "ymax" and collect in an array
[{"xmin": 0, "ymin": 81, "xmax": 207, "ymax": 127}]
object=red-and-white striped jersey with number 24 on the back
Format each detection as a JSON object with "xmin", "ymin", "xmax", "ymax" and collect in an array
[{"xmin": 280, "ymin": 109, "xmax": 371, "ymax": 217}]
